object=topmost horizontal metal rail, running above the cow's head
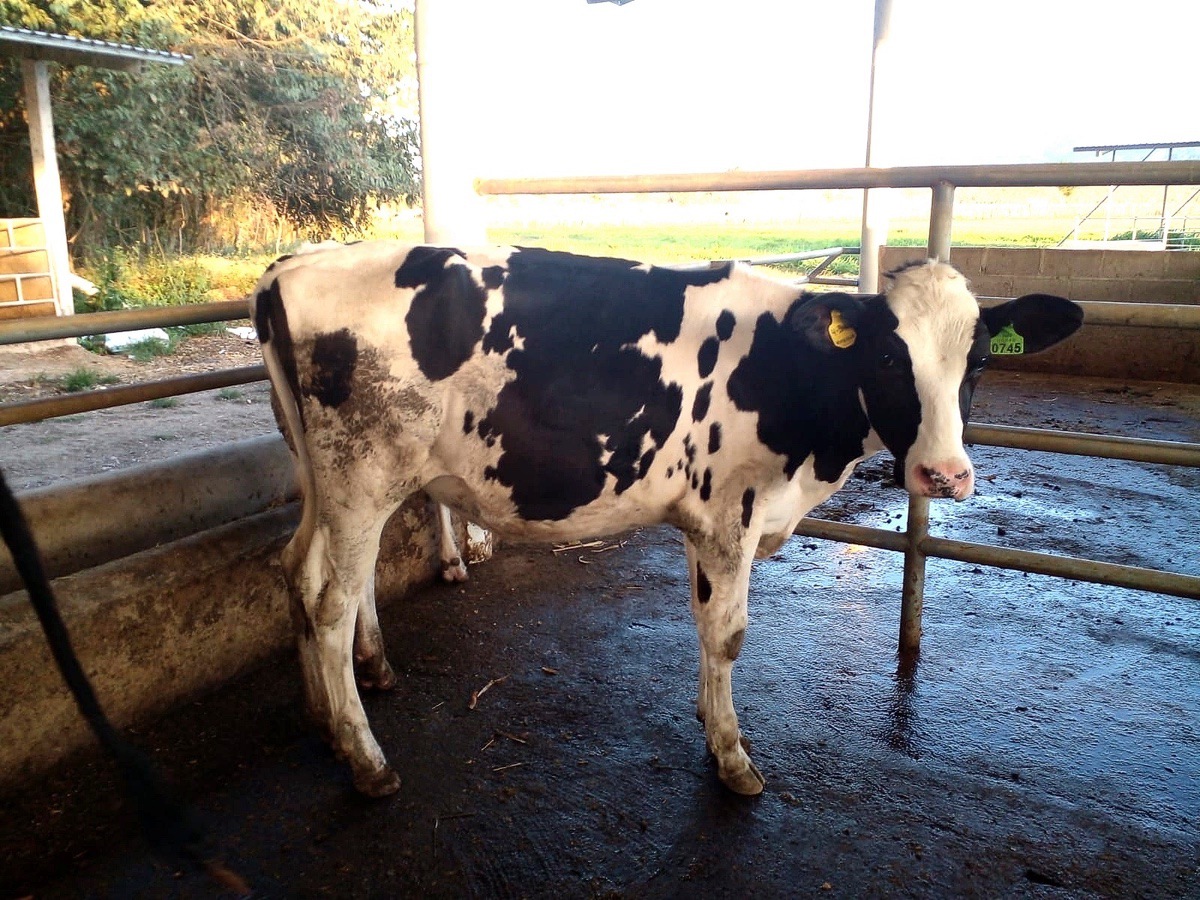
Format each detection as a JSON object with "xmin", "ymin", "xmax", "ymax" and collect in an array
[{"xmin": 475, "ymin": 160, "xmax": 1200, "ymax": 196}]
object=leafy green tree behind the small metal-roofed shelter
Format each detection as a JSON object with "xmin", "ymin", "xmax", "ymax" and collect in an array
[{"xmin": 0, "ymin": 0, "xmax": 419, "ymax": 252}]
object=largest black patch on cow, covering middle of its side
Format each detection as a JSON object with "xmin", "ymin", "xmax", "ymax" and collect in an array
[{"xmin": 480, "ymin": 250, "xmax": 730, "ymax": 520}]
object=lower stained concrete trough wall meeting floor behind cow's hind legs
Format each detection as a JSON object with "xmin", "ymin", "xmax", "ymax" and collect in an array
[{"xmin": 0, "ymin": 494, "xmax": 439, "ymax": 786}]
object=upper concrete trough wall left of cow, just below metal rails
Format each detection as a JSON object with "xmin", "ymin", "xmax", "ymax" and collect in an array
[{"xmin": 0, "ymin": 434, "xmax": 298, "ymax": 594}]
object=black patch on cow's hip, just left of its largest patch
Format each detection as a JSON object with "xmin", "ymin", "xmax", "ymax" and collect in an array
[{"xmin": 396, "ymin": 247, "xmax": 487, "ymax": 382}]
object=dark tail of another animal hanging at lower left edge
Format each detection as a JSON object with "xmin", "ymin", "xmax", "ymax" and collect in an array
[{"xmin": 0, "ymin": 473, "xmax": 251, "ymax": 895}]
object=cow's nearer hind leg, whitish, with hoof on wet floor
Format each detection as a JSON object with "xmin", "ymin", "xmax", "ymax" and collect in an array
[{"xmin": 283, "ymin": 509, "xmax": 400, "ymax": 797}]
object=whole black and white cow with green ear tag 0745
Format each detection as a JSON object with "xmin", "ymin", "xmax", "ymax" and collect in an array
[{"xmin": 251, "ymin": 242, "xmax": 1081, "ymax": 796}]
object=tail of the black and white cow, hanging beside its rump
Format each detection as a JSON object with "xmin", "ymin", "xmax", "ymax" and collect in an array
[{"xmin": 250, "ymin": 275, "xmax": 317, "ymax": 570}]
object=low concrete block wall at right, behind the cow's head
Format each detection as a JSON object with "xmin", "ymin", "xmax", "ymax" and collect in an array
[{"xmin": 880, "ymin": 247, "xmax": 1200, "ymax": 384}]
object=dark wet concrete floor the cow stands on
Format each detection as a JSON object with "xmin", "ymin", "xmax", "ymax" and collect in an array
[{"xmin": 0, "ymin": 373, "xmax": 1200, "ymax": 898}]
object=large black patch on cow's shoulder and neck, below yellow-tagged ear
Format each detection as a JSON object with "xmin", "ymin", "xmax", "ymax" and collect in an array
[{"xmin": 727, "ymin": 294, "xmax": 878, "ymax": 481}]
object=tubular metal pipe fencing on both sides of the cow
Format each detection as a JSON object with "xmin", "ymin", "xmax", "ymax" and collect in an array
[{"xmin": 7, "ymin": 162, "xmax": 1200, "ymax": 650}]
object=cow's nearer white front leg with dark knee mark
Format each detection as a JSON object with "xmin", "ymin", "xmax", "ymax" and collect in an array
[{"xmin": 685, "ymin": 536, "xmax": 763, "ymax": 794}]
